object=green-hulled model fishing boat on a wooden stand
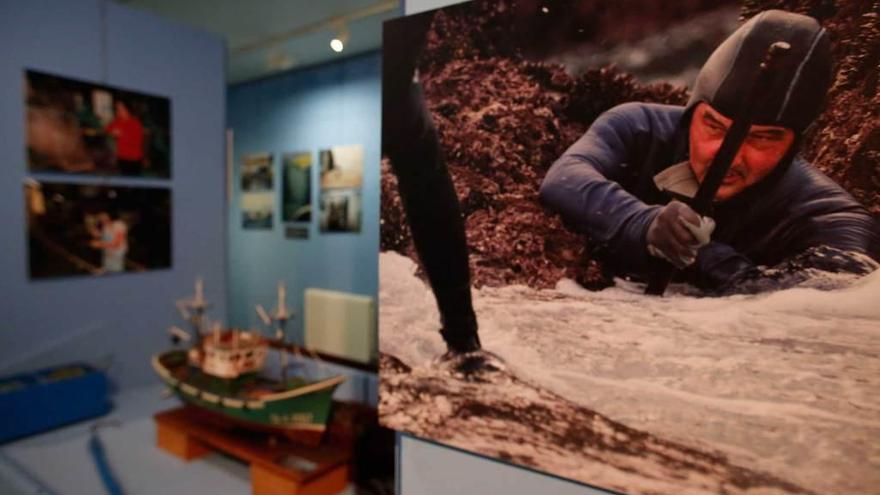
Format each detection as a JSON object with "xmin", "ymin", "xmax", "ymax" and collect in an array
[{"xmin": 152, "ymin": 281, "xmax": 345, "ymax": 444}]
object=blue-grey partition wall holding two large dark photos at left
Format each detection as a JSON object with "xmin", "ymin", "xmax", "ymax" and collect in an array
[{"xmin": 0, "ymin": 0, "xmax": 226, "ymax": 387}]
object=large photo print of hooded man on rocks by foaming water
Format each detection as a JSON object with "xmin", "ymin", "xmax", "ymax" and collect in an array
[{"xmin": 378, "ymin": 0, "xmax": 880, "ymax": 494}]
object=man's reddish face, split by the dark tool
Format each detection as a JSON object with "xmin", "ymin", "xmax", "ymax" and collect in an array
[{"xmin": 690, "ymin": 102, "xmax": 794, "ymax": 201}]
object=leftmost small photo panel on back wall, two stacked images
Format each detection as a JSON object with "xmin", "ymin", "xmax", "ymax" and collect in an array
[{"xmin": 241, "ymin": 153, "xmax": 275, "ymax": 230}]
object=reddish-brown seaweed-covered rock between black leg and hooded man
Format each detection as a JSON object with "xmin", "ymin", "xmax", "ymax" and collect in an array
[{"xmin": 422, "ymin": 56, "xmax": 687, "ymax": 287}]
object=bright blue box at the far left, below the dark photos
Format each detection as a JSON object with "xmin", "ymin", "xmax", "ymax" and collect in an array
[{"xmin": 0, "ymin": 363, "xmax": 111, "ymax": 443}]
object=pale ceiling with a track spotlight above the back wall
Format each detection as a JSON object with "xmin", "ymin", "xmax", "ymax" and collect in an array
[{"xmin": 116, "ymin": 0, "xmax": 402, "ymax": 84}]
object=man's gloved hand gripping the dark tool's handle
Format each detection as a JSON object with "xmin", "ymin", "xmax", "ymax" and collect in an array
[{"xmin": 647, "ymin": 201, "xmax": 715, "ymax": 268}]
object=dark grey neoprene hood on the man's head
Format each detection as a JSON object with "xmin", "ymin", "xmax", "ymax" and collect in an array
[{"xmin": 687, "ymin": 10, "xmax": 831, "ymax": 134}]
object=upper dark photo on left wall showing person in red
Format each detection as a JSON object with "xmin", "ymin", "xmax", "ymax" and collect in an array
[{"xmin": 25, "ymin": 70, "xmax": 171, "ymax": 178}]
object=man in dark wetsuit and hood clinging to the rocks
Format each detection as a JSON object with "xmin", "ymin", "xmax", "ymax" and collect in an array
[{"xmin": 540, "ymin": 10, "xmax": 880, "ymax": 293}]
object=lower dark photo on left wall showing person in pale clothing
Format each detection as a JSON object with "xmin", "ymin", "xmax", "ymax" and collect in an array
[{"xmin": 24, "ymin": 181, "xmax": 171, "ymax": 279}]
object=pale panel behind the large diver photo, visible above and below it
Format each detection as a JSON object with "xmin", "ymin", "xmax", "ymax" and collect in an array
[{"xmin": 397, "ymin": 0, "xmax": 609, "ymax": 495}]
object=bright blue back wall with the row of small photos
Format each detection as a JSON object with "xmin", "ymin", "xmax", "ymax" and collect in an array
[{"xmin": 228, "ymin": 53, "xmax": 381, "ymax": 401}]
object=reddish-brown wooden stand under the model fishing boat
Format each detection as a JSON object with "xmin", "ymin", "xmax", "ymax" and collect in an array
[{"xmin": 155, "ymin": 406, "xmax": 351, "ymax": 495}]
